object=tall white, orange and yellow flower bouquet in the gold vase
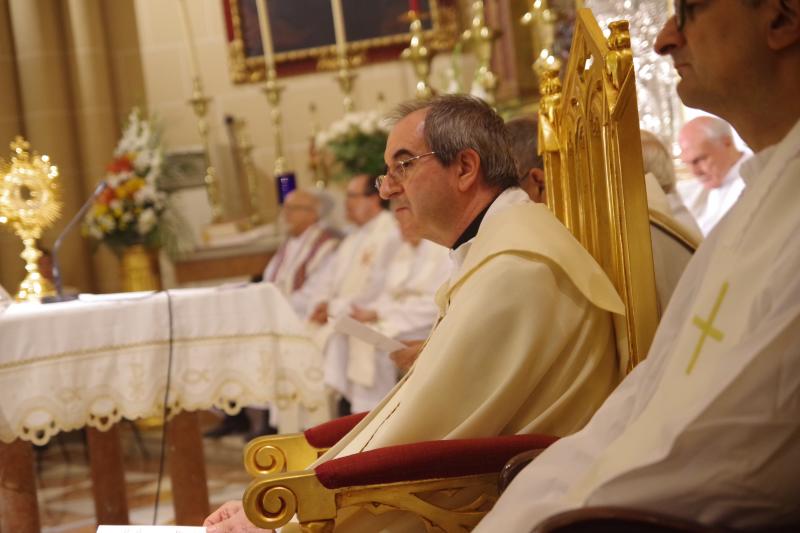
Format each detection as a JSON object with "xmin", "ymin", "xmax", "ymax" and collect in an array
[{"xmin": 83, "ymin": 108, "xmax": 166, "ymax": 255}]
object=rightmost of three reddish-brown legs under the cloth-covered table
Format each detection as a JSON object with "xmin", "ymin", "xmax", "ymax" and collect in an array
[{"xmin": 167, "ymin": 412, "xmax": 210, "ymax": 526}]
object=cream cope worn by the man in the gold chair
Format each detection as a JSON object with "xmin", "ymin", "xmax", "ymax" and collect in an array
[{"xmin": 288, "ymin": 188, "xmax": 624, "ymax": 531}]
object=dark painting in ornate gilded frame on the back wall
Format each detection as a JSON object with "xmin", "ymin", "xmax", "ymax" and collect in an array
[{"xmin": 222, "ymin": 0, "xmax": 460, "ymax": 83}]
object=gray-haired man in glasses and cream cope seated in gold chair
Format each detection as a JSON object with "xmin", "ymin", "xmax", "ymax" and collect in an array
[{"xmin": 206, "ymin": 95, "xmax": 625, "ymax": 532}]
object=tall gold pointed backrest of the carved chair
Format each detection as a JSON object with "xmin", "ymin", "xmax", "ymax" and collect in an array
[{"xmin": 539, "ymin": 9, "xmax": 659, "ymax": 370}]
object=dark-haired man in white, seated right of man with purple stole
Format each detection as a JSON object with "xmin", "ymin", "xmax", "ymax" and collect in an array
[{"xmin": 307, "ymin": 174, "xmax": 402, "ymax": 414}]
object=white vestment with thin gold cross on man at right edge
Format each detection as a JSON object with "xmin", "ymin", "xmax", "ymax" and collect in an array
[{"xmin": 475, "ymin": 118, "xmax": 800, "ymax": 533}]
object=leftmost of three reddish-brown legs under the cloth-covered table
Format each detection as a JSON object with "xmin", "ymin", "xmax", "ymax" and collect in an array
[{"xmin": 0, "ymin": 440, "xmax": 39, "ymax": 533}]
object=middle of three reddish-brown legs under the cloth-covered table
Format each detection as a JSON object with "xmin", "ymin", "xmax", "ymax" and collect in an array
[{"xmin": 86, "ymin": 424, "xmax": 129, "ymax": 525}]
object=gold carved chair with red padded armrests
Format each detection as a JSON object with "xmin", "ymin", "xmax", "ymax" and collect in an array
[{"xmin": 243, "ymin": 9, "xmax": 658, "ymax": 532}]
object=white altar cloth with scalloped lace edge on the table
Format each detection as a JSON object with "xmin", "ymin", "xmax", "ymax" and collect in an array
[{"xmin": 0, "ymin": 283, "xmax": 327, "ymax": 444}]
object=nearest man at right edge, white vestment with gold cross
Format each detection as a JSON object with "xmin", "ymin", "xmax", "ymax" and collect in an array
[{"xmin": 475, "ymin": 0, "xmax": 800, "ymax": 533}]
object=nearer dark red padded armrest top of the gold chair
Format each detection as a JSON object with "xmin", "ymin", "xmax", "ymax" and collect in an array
[{"xmin": 314, "ymin": 435, "xmax": 558, "ymax": 489}]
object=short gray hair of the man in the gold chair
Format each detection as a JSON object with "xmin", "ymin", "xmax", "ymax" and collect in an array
[{"xmin": 386, "ymin": 94, "xmax": 517, "ymax": 189}]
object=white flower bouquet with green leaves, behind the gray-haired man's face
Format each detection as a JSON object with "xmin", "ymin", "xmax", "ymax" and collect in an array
[{"xmin": 314, "ymin": 111, "xmax": 389, "ymax": 180}]
